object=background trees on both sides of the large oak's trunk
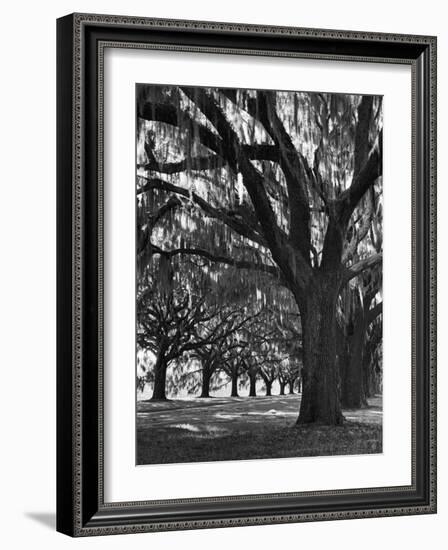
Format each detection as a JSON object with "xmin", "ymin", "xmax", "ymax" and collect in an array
[{"xmin": 137, "ymin": 253, "xmax": 382, "ymax": 408}]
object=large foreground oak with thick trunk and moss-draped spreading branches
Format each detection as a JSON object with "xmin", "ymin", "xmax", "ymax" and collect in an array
[{"xmin": 137, "ymin": 85, "xmax": 382, "ymax": 424}]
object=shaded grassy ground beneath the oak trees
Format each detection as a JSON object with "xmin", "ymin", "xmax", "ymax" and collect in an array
[{"xmin": 137, "ymin": 395, "xmax": 382, "ymax": 464}]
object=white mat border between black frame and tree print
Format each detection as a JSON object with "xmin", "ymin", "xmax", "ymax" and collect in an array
[{"xmin": 104, "ymin": 48, "xmax": 411, "ymax": 502}]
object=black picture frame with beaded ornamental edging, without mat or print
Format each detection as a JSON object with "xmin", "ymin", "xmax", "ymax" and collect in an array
[{"xmin": 57, "ymin": 14, "xmax": 436, "ymax": 536}]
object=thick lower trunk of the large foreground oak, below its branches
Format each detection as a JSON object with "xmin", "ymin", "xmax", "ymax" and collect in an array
[{"xmin": 297, "ymin": 280, "xmax": 344, "ymax": 425}]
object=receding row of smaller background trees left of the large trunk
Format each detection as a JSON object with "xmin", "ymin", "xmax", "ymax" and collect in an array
[{"xmin": 137, "ymin": 256, "xmax": 301, "ymax": 399}]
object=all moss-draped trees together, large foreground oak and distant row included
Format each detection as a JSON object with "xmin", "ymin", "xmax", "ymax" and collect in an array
[{"xmin": 137, "ymin": 85, "xmax": 382, "ymax": 424}]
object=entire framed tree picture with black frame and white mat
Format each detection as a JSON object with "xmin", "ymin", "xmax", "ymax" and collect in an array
[{"xmin": 57, "ymin": 14, "xmax": 436, "ymax": 536}]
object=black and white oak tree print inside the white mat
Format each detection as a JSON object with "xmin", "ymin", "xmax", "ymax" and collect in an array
[{"xmin": 135, "ymin": 83, "xmax": 387, "ymax": 465}]
